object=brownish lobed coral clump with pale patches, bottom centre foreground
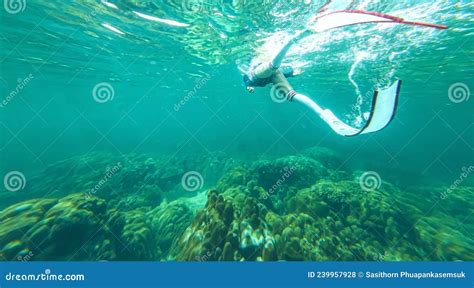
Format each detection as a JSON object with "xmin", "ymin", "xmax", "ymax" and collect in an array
[{"xmin": 175, "ymin": 191, "xmax": 276, "ymax": 261}]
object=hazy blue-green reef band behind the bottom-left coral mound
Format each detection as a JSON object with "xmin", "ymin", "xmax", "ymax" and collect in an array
[{"xmin": 0, "ymin": 152, "xmax": 237, "ymax": 211}]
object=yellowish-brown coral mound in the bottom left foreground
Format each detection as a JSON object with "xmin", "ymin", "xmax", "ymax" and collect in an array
[{"xmin": 0, "ymin": 193, "xmax": 193, "ymax": 261}]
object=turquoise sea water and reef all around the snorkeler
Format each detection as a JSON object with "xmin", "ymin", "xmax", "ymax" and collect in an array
[{"xmin": 0, "ymin": 0, "xmax": 474, "ymax": 261}]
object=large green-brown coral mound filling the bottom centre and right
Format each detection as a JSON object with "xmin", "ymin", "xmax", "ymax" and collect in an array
[{"xmin": 174, "ymin": 163, "xmax": 473, "ymax": 261}]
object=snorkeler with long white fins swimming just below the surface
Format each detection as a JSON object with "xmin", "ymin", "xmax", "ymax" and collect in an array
[{"xmin": 244, "ymin": 10, "xmax": 448, "ymax": 136}]
